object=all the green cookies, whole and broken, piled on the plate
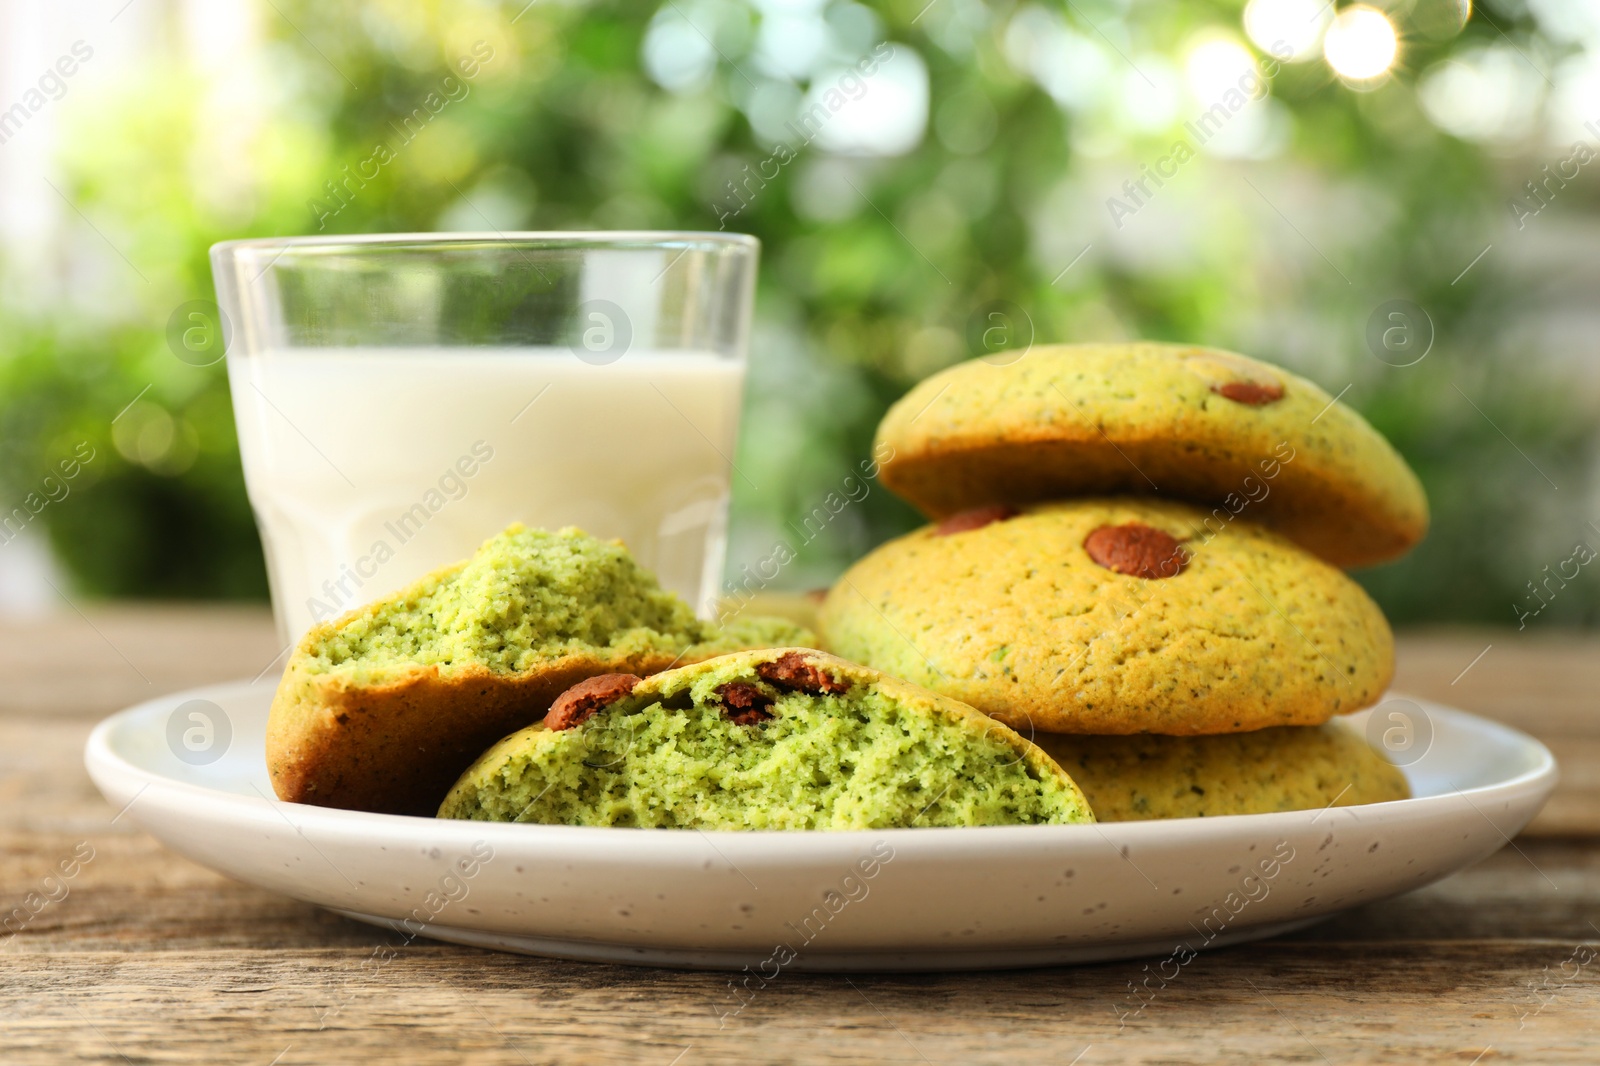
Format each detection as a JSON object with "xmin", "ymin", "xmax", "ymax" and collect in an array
[{"xmin": 266, "ymin": 344, "xmax": 1427, "ymax": 829}]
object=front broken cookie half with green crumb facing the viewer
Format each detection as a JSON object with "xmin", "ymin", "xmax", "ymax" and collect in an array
[{"xmin": 438, "ymin": 650, "xmax": 1093, "ymax": 829}]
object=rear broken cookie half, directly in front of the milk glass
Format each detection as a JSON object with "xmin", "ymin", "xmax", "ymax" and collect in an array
[{"xmin": 267, "ymin": 525, "xmax": 814, "ymax": 815}]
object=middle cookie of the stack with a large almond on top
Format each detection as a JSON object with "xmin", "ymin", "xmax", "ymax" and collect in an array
[{"xmin": 818, "ymin": 498, "xmax": 1394, "ymax": 736}]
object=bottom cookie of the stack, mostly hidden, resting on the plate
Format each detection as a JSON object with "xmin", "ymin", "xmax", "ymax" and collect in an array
[{"xmin": 1034, "ymin": 722, "xmax": 1411, "ymax": 821}]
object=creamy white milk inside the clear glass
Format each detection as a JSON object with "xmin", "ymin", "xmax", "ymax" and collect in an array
[{"xmin": 227, "ymin": 347, "xmax": 744, "ymax": 642}]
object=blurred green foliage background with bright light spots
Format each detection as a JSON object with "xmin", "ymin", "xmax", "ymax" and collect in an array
[{"xmin": 0, "ymin": 0, "xmax": 1600, "ymax": 626}]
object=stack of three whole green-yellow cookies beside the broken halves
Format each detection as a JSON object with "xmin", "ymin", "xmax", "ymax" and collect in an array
[{"xmin": 819, "ymin": 344, "xmax": 1427, "ymax": 821}]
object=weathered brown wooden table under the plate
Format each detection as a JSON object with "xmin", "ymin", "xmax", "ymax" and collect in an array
[{"xmin": 0, "ymin": 607, "xmax": 1600, "ymax": 1066}]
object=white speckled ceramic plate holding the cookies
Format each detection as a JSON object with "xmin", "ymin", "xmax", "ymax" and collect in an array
[{"xmin": 85, "ymin": 683, "xmax": 1555, "ymax": 984}]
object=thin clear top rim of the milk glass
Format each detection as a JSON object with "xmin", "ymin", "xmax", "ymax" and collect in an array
[{"xmin": 210, "ymin": 229, "xmax": 762, "ymax": 258}]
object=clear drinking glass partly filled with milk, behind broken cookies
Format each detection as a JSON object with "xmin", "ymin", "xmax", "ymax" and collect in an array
[{"xmin": 211, "ymin": 232, "xmax": 758, "ymax": 643}]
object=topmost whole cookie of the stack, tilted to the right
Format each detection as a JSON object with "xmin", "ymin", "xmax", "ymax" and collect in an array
[{"xmin": 877, "ymin": 343, "xmax": 1427, "ymax": 567}]
